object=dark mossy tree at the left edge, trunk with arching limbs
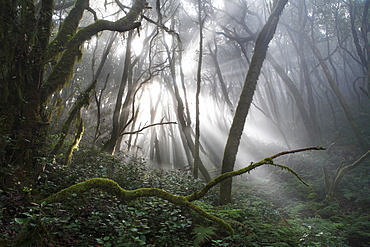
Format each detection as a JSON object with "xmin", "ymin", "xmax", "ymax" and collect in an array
[{"xmin": 0, "ymin": 0, "xmax": 146, "ymax": 186}]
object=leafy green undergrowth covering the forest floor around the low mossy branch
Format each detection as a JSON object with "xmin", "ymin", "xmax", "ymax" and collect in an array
[{"xmin": 0, "ymin": 147, "xmax": 370, "ymax": 247}]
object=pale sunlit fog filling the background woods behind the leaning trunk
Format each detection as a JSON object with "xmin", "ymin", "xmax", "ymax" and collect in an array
[{"xmin": 55, "ymin": 0, "xmax": 370, "ymax": 181}]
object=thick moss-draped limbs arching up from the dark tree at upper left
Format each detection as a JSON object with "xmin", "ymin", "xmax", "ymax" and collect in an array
[{"xmin": 41, "ymin": 0, "xmax": 145, "ymax": 103}]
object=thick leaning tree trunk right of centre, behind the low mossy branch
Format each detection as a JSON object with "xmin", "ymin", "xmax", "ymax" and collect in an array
[{"xmin": 219, "ymin": 0, "xmax": 288, "ymax": 204}]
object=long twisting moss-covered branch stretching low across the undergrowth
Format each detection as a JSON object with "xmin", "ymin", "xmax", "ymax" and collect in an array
[{"xmin": 41, "ymin": 147, "xmax": 324, "ymax": 235}]
